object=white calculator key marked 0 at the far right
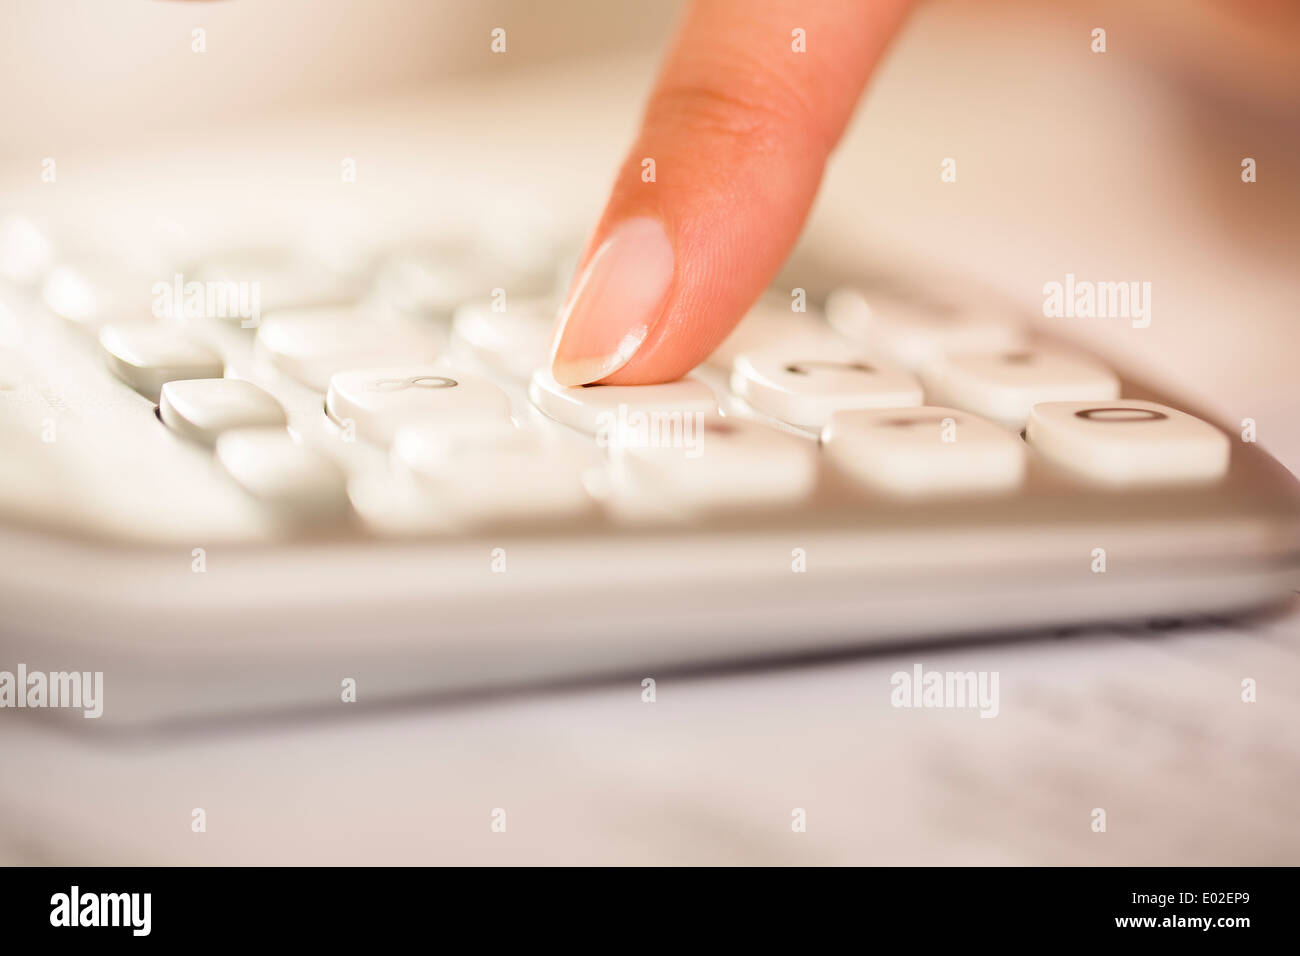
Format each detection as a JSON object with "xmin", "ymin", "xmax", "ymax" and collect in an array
[{"xmin": 1024, "ymin": 399, "xmax": 1229, "ymax": 485}]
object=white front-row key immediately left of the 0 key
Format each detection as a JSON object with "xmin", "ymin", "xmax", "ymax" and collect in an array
[{"xmin": 822, "ymin": 406, "xmax": 1026, "ymax": 496}]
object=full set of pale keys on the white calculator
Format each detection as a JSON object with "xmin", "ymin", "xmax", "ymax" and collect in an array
[{"xmin": 42, "ymin": 234, "xmax": 1248, "ymax": 535}]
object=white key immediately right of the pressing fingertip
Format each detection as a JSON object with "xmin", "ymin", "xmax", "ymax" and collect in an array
[{"xmin": 731, "ymin": 346, "xmax": 920, "ymax": 428}]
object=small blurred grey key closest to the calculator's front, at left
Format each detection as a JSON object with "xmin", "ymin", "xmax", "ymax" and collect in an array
[{"xmin": 216, "ymin": 428, "xmax": 347, "ymax": 520}]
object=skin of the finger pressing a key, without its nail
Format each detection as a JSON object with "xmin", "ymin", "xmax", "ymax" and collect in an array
[{"xmin": 556, "ymin": 0, "xmax": 910, "ymax": 385}]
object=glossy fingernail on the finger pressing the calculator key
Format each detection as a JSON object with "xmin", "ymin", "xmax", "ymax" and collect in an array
[{"xmin": 551, "ymin": 217, "xmax": 672, "ymax": 385}]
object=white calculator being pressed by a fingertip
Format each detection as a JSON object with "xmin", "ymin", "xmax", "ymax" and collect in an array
[{"xmin": 0, "ymin": 219, "xmax": 1300, "ymax": 726}]
